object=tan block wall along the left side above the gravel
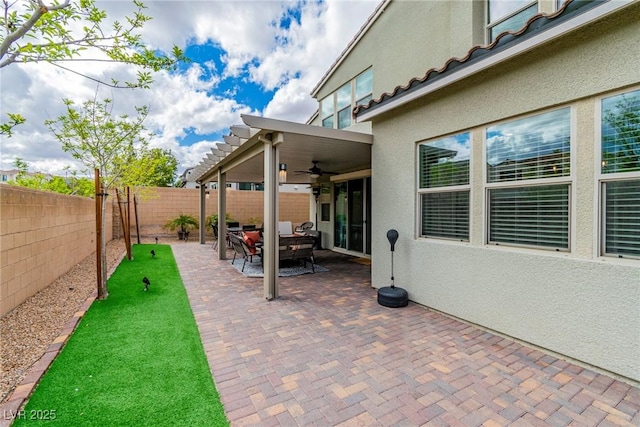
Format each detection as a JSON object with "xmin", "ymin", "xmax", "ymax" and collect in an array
[{"xmin": 0, "ymin": 184, "xmax": 112, "ymax": 317}]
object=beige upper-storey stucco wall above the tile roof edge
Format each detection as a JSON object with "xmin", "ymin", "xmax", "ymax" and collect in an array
[{"xmin": 312, "ymin": 1, "xmax": 484, "ymax": 124}]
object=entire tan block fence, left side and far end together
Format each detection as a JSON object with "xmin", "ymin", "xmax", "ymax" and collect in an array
[{"xmin": 0, "ymin": 183, "xmax": 309, "ymax": 317}]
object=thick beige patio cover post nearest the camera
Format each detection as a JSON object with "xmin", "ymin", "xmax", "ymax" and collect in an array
[{"xmin": 260, "ymin": 133, "xmax": 283, "ymax": 300}]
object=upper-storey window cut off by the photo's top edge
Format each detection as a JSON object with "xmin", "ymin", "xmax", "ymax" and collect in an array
[{"xmin": 487, "ymin": 0, "xmax": 538, "ymax": 42}]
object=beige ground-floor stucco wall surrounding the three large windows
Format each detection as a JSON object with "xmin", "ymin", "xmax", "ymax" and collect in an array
[{"xmin": 368, "ymin": 2, "xmax": 640, "ymax": 381}]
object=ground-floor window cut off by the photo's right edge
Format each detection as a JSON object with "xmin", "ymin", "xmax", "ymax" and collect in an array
[{"xmin": 598, "ymin": 89, "xmax": 640, "ymax": 258}]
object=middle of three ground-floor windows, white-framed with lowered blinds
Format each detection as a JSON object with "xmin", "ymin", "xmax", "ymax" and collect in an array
[{"xmin": 485, "ymin": 107, "xmax": 571, "ymax": 251}]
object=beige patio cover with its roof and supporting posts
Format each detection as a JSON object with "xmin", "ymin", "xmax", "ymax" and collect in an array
[{"xmin": 191, "ymin": 115, "xmax": 373, "ymax": 300}]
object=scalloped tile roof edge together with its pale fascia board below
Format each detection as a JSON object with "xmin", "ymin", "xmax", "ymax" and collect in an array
[{"xmin": 353, "ymin": 0, "xmax": 632, "ymax": 120}]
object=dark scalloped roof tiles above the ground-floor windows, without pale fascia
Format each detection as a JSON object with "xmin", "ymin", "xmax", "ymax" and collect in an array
[{"xmin": 353, "ymin": 0, "xmax": 610, "ymax": 116}]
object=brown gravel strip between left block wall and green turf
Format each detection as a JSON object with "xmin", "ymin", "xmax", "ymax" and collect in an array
[{"xmin": 0, "ymin": 240, "xmax": 151, "ymax": 403}]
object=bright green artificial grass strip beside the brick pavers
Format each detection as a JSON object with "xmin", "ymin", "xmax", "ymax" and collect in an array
[{"xmin": 14, "ymin": 245, "xmax": 229, "ymax": 427}]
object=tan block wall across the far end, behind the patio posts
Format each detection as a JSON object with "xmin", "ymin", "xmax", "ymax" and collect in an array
[{"xmin": 120, "ymin": 188, "xmax": 310, "ymax": 241}]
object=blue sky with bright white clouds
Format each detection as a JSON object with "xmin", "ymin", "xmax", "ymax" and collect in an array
[{"xmin": 0, "ymin": 0, "xmax": 379, "ymax": 174}]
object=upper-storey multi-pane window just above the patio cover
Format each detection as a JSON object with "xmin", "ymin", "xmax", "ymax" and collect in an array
[{"xmin": 320, "ymin": 68, "xmax": 373, "ymax": 129}]
